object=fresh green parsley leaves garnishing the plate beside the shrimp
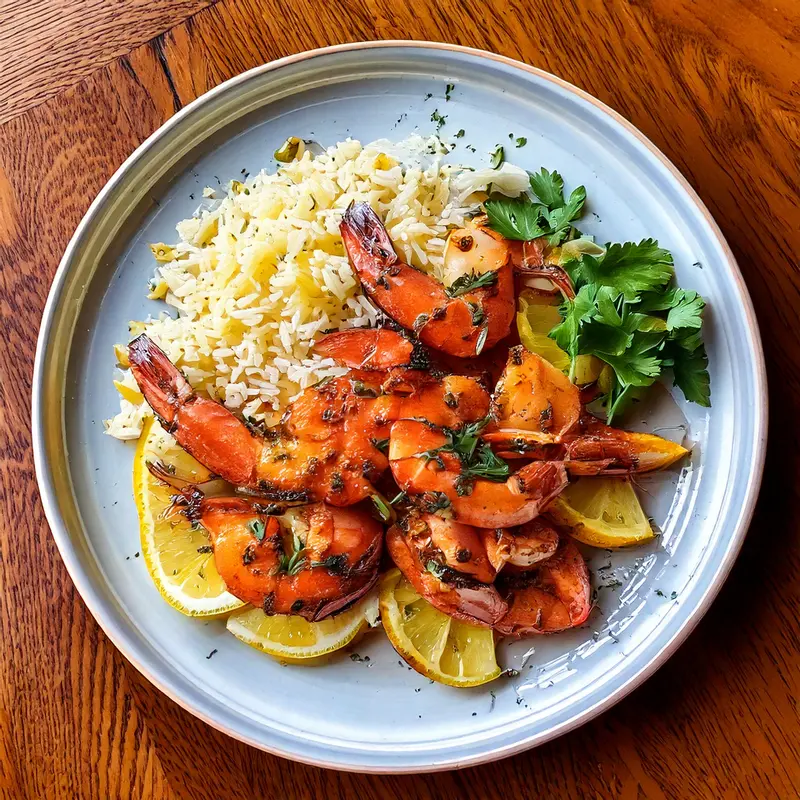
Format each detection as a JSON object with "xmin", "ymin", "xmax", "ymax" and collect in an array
[{"xmin": 484, "ymin": 167, "xmax": 711, "ymax": 423}]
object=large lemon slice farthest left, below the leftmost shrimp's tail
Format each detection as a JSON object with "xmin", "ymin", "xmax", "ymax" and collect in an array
[{"xmin": 133, "ymin": 417, "xmax": 244, "ymax": 617}]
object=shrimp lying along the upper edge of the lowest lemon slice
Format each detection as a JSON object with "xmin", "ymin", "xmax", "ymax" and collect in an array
[{"xmin": 386, "ymin": 513, "xmax": 508, "ymax": 627}]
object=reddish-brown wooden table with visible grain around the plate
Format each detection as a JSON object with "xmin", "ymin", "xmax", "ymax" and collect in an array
[{"xmin": 0, "ymin": 0, "xmax": 800, "ymax": 800}]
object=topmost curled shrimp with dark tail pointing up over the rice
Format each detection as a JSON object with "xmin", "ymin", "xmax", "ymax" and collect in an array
[{"xmin": 339, "ymin": 203, "xmax": 515, "ymax": 358}]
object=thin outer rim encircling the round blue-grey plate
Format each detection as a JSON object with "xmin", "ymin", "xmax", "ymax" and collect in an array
[{"xmin": 31, "ymin": 39, "xmax": 769, "ymax": 774}]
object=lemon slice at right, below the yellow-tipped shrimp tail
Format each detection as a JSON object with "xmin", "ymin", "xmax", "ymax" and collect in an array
[{"xmin": 547, "ymin": 478, "xmax": 655, "ymax": 547}]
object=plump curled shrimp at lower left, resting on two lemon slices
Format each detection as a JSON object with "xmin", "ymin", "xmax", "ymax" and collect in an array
[{"xmin": 195, "ymin": 497, "xmax": 383, "ymax": 621}]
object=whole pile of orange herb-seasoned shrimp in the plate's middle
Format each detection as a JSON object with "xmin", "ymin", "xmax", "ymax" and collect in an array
[{"xmin": 129, "ymin": 203, "xmax": 685, "ymax": 637}]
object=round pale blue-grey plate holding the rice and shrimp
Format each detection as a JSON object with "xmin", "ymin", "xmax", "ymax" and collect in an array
[{"xmin": 33, "ymin": 42, "xmax": 767, "ymax": 772}]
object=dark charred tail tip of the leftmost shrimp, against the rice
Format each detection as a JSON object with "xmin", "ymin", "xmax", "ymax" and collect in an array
[{"xmin": 128, "ymin": 333, "xmax": 194, "ymax": 426}]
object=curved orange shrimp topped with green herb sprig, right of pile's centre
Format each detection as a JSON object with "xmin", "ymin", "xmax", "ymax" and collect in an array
[{"xmin": 389, "ymin": 420, "xmax": 567, "ymax": 528}]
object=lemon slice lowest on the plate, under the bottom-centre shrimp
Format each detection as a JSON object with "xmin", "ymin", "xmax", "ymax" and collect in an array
[{"xmin": 380, "ymin": 569, "xmax": 500, "ymax": 687}]
